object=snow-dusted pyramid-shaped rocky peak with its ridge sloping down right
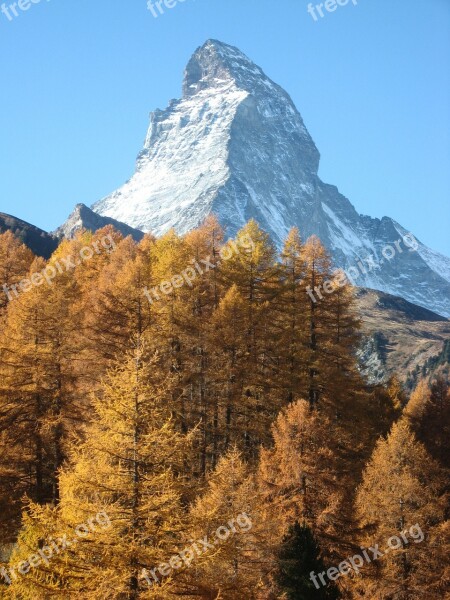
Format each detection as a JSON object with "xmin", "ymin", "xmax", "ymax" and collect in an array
[{"xmin": 92, "ymin": 40, "xmax": 450, "ymax": 316}]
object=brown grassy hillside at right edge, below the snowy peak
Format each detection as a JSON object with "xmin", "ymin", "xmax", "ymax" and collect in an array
[{"xmin": 357, "ymin": 289, "xmax": 450, "ymax": 387}]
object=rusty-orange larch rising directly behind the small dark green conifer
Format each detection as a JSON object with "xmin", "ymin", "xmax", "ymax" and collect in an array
[{"xmin": 258, "ymin": 400, "xmax": 349, "ymax": 558}]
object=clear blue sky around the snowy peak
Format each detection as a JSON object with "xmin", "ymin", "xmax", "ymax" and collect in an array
[{"xmin": 0, "ymin": 0, "xmax": 450, "ymax": 255}]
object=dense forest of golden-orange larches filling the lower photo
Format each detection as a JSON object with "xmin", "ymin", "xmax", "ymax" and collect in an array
[{"xmin": 0, "ymin": 217, "xmax": 450, "ymax": 600}]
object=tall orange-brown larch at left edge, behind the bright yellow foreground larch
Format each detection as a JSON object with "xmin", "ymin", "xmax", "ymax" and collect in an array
[{"xmin": 0, "ymin": 241, "xmax": 81, "ymax": 516}]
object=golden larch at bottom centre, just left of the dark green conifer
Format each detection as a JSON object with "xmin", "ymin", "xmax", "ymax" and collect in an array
[{"xmin": 185, "ymin": 449, "xmax": 262, "ymax": 600}]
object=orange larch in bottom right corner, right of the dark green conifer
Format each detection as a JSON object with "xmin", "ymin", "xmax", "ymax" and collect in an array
[{"xmin": 355, "ymin": 418, "xmax": 448, "ymax": 599}]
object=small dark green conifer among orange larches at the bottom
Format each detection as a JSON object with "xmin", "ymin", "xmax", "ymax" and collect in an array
[{"xmin": 275, "ymin": 521, "xmax": 341, "ymax": 600}]
